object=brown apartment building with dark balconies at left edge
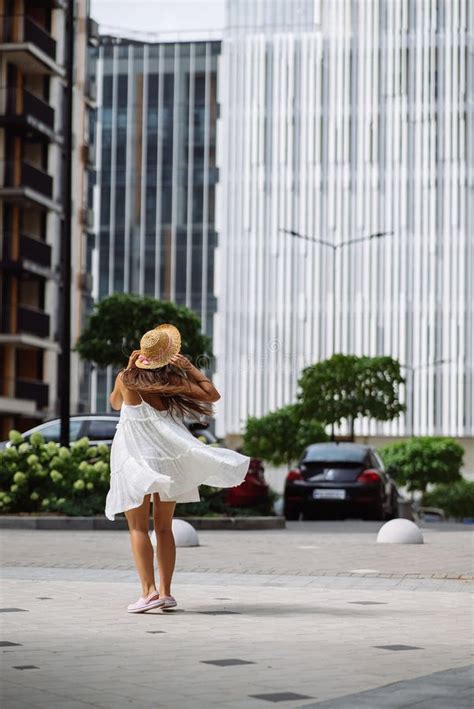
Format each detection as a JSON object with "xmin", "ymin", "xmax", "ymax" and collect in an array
[{"xmin": 0, "ymin": 0, "xmax": 97, "ymax": 439}]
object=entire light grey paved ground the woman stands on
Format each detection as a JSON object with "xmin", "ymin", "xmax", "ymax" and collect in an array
[{"xmin": 0, "ymin": 522, "xmax": 474, "ymax": 709}]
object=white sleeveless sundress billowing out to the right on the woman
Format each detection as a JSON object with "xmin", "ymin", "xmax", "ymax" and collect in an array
[{"xmin": 105, "ymin": 392, "xmax": 250, "ymax": 520}]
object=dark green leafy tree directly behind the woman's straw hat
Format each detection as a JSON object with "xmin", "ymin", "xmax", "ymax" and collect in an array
[{"xmin": 76, "ymin": 293, "xmax": 212, "ymax": 368}]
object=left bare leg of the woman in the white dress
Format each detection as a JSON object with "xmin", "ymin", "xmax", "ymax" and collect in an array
[{"xmin": 125, "ymin": 495, "xmax": 156, "ymax": 596}]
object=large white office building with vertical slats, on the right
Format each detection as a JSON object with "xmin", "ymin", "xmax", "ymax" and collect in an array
[{"xmin": 214, "ymin": 0, "xmax": 474, "ymax": 442}]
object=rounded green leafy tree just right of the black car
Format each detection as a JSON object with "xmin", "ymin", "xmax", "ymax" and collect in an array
[{"xmin": 379, "ymin": 436, "xmax": 464, "ymax": 492}]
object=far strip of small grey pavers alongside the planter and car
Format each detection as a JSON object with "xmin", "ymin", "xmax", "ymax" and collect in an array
[{"xmin": 0, "ymin": 520, "xmax": 474, "ymax": 579}]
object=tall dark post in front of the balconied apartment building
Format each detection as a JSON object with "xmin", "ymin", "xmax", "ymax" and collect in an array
[{"xmin": 58, "ymin": 0, "xmax": 75, "ymax": 446}]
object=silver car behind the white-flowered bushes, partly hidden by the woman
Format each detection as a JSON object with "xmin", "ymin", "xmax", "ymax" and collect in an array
[{"xmin": 0, "ymin": 412, "xmax": 217, "ymax": 450}]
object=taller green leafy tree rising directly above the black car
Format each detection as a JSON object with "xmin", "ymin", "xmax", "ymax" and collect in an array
[{"xmin": 298, "ymin": 354, "xmax": 405, "ymax": 438}]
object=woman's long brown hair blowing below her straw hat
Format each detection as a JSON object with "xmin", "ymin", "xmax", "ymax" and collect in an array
[{"xmin": 122, "ymin": 364, "xmax": 213, "ymax": 416}]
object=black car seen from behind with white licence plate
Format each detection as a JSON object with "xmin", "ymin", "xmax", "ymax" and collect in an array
[{"xmin": 284, "ymin": 443, "xmax": 398, "ymax": 520}]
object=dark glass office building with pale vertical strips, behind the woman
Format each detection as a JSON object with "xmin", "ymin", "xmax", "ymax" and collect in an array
[{"xmin": 93, "ymin": 36, "xmax": 220, "ymax": 409}]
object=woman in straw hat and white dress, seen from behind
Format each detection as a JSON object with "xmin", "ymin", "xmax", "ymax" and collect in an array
[{"xmin": 105, "ymin": 324, "xmax": 250, "ymax": 613}]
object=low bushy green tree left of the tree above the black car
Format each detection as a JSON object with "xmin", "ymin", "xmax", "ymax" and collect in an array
[{"xmin": 243, "ymin": 404, "xmax": 328, "ymax": 466}]
